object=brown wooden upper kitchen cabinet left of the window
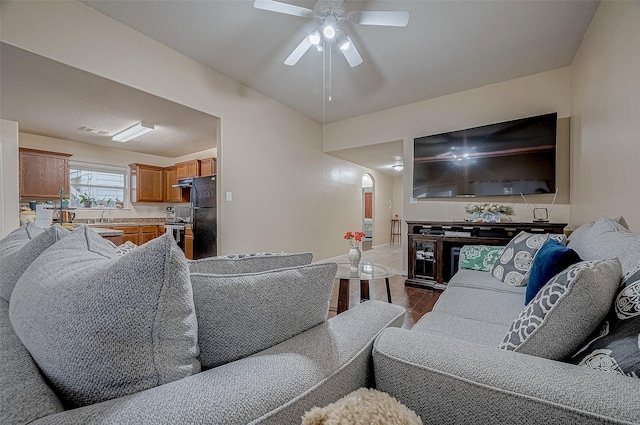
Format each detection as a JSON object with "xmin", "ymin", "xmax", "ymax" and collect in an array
[{"xmin": 19, "ymin": 148, "xmax": 71, "ymax": 200}]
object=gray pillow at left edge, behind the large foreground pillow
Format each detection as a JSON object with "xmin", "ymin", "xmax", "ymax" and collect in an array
[{"xmin": 0, "ymin": 223, "xmax": 69, "ymax": 301}]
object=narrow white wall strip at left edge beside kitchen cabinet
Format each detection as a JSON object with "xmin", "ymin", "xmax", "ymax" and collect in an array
[{"xmin": 0, "ymin": 120, "xmax": 20, "ymax": 238}]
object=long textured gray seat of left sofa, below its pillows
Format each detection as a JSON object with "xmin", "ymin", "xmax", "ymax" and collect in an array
[{"xmin": 34, "ymin": 301, "xmax": 404, "ymax": 425}]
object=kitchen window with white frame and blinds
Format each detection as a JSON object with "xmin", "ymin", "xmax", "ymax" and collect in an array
[{"xmin": 69, "ymin": 161, "xmax": 129, "ymax": 208}]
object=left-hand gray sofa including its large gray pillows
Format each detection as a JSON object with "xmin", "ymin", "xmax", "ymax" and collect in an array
[{"xmin": 0, "ymin": 224, "xmax": 404, "ymax": 425}]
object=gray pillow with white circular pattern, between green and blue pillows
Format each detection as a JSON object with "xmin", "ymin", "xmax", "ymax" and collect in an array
[{"xmin": 491, "ymin": 232, "xmax": 565, "ymax": 286}]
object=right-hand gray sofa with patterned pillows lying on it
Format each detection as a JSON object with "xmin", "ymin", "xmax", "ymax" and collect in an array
[{"xmin": 373, "ymin": 218, "xmax": 640, "ymax": 424}]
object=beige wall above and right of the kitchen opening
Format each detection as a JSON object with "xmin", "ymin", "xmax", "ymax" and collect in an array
[{"xmin": 0, "ymin": 1, "xmax": 368, "ymax": 259}]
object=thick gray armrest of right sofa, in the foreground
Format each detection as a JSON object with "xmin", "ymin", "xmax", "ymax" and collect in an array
[{"xmin": 373, "ymin": 329, "xmax": 640, "ymax": 424}]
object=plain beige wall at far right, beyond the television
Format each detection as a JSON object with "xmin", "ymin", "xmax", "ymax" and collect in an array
[{"xmin": 571, "ymin": 1, "xmax": 640, "ymax": 232}]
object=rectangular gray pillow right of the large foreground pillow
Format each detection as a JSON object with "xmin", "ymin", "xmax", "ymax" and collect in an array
[{"xmin": 191, "ymin": 263, "xmax": 337, "ymax": 369}]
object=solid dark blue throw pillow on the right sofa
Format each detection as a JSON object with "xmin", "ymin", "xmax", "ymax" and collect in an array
[{"xmin": 524, "ymin": 239, "xmax": 582, "ymax": 304}]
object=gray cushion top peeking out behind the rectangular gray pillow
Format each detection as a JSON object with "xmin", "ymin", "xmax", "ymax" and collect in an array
[{"xmin": 189, "ymin": 252, "xmax": 313, "ymax": 274}]
